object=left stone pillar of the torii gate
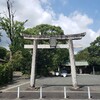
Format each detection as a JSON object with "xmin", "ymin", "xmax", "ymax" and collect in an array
[{"xmin": 30, "ymin": 40, "xmax": 37, "ymax": 87}]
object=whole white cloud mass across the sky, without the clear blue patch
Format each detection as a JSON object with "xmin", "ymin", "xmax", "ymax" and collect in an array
[{"xmin": 0, "ymin": 0, "xmax": 100, "ymax": 47}]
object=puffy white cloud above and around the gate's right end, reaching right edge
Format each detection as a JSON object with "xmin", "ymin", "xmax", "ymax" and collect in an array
[{"xmin": 53, "ymin": 12, "xmax": 100, "ymax": 48}]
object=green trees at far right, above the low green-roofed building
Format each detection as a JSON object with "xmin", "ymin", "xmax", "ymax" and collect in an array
[{"xmin": 76, "ymin": 36, "xmax": 100, "ymax": 66}]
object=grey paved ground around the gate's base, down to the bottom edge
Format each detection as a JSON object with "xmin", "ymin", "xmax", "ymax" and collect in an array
[{"xmin": 0, "ymin": 75, "xmax": 100, "ymax": 100}]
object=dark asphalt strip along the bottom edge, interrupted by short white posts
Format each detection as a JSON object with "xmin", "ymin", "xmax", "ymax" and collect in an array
[{"xmin": 0, "ymin": 92, "xmax": 100, "ymax": 100}]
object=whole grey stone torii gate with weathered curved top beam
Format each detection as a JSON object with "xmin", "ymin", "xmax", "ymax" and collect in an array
[{"xmin": 23, "ymin": 32, "xmax": 86, "ymax": 89}]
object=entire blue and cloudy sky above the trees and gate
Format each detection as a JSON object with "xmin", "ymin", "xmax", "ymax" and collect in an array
[{"xmin": 0, "ymin": 0, "xmax": 100, "ymax": 48}]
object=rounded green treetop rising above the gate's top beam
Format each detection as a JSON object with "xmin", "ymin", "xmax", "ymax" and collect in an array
[{"xmin": 25, "ymin": 24, "xmax": 63, "ymax": 35}]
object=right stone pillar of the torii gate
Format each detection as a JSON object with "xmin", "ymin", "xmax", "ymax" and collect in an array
[{"xmin": 68, "ymin": 39, "xmax": 78, "ymax": 89}]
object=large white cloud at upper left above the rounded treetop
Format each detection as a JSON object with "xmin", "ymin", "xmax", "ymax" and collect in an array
[{"xmin": 13, "ymin": 0, "xmax": 54, "ymax": 27}]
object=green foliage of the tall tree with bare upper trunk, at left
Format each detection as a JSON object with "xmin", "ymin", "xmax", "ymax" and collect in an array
[{"xmin": 0, "ymin": 17, "xmax": 26, "ymax": 54}]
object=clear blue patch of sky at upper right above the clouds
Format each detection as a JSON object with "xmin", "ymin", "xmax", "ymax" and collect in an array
[{"xmin": 49, "ymin": 0, "xmax": 100, "ymax": 31}]
